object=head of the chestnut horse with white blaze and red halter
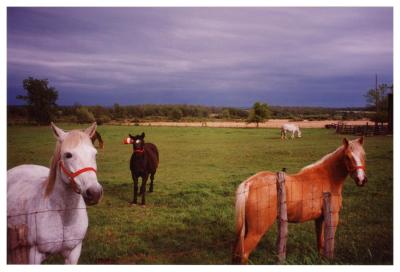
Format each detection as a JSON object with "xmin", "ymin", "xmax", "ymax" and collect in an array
[{"xmin": 343, "ymin": 137, "xmax": 368, "ymax": 186}]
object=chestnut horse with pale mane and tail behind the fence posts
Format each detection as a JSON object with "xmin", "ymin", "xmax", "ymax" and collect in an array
[{"xmin": 232, "ymin": 137, "xmax": 367, "ymax": 264}]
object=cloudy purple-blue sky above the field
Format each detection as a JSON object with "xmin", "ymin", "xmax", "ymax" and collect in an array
[{"xmin": 7, "ymin": 7, "xmax": 393, "ymax": 107}]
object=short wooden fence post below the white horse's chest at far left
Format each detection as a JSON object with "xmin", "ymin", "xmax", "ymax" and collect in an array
[{"xmin": 7, "ymin": 224, "xmax": 29, "ymax": 264}]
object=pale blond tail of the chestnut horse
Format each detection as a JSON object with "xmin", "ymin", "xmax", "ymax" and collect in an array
[{"xmin": 232, "ymin": 181, "xmax": 249, "ymax": 263}]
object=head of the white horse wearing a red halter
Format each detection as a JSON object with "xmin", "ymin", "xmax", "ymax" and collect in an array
[{"xmin": 51, "ymin": 123, "xmax": 103, "ymax": 205}]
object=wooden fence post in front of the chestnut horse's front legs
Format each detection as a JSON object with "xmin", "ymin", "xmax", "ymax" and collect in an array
[{"xmin": 323, "ymin": 192, "xmax": 335, "ymax": 259}]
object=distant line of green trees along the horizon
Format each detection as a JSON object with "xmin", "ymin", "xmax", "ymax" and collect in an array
[{"xmin": 7, "ymin": 77, "xmax": 387, "ymax": 125}]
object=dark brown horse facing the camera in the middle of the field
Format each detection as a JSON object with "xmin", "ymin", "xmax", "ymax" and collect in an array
[{"xmin": 125, "ymin": 133, "xmax": 159, "ymax": 205}]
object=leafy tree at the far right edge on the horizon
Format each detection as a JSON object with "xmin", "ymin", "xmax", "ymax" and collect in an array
[{"xmin": 364, "ymin": 84, "xmax": 389, "ymax": 122}]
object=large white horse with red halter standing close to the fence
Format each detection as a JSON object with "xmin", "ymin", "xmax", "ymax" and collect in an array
[{"xmin": 7, "ymin": 123, "xmax": 103, "ymax": 264}]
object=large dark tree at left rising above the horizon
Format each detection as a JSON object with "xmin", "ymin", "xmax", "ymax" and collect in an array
[{"xmin": 17, "ymin": 77, "xmax": 58, "ymax": 125}]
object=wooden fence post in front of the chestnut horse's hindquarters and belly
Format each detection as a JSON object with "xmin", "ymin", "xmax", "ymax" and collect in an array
[{"xmin": 276, "ymin": 172, "xmax": 288, "ymax": 263}]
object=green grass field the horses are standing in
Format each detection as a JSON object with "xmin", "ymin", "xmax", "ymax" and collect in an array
[{"xmin": 7, "ymin": 125, "xmax": 393, "ymax": 264}]
